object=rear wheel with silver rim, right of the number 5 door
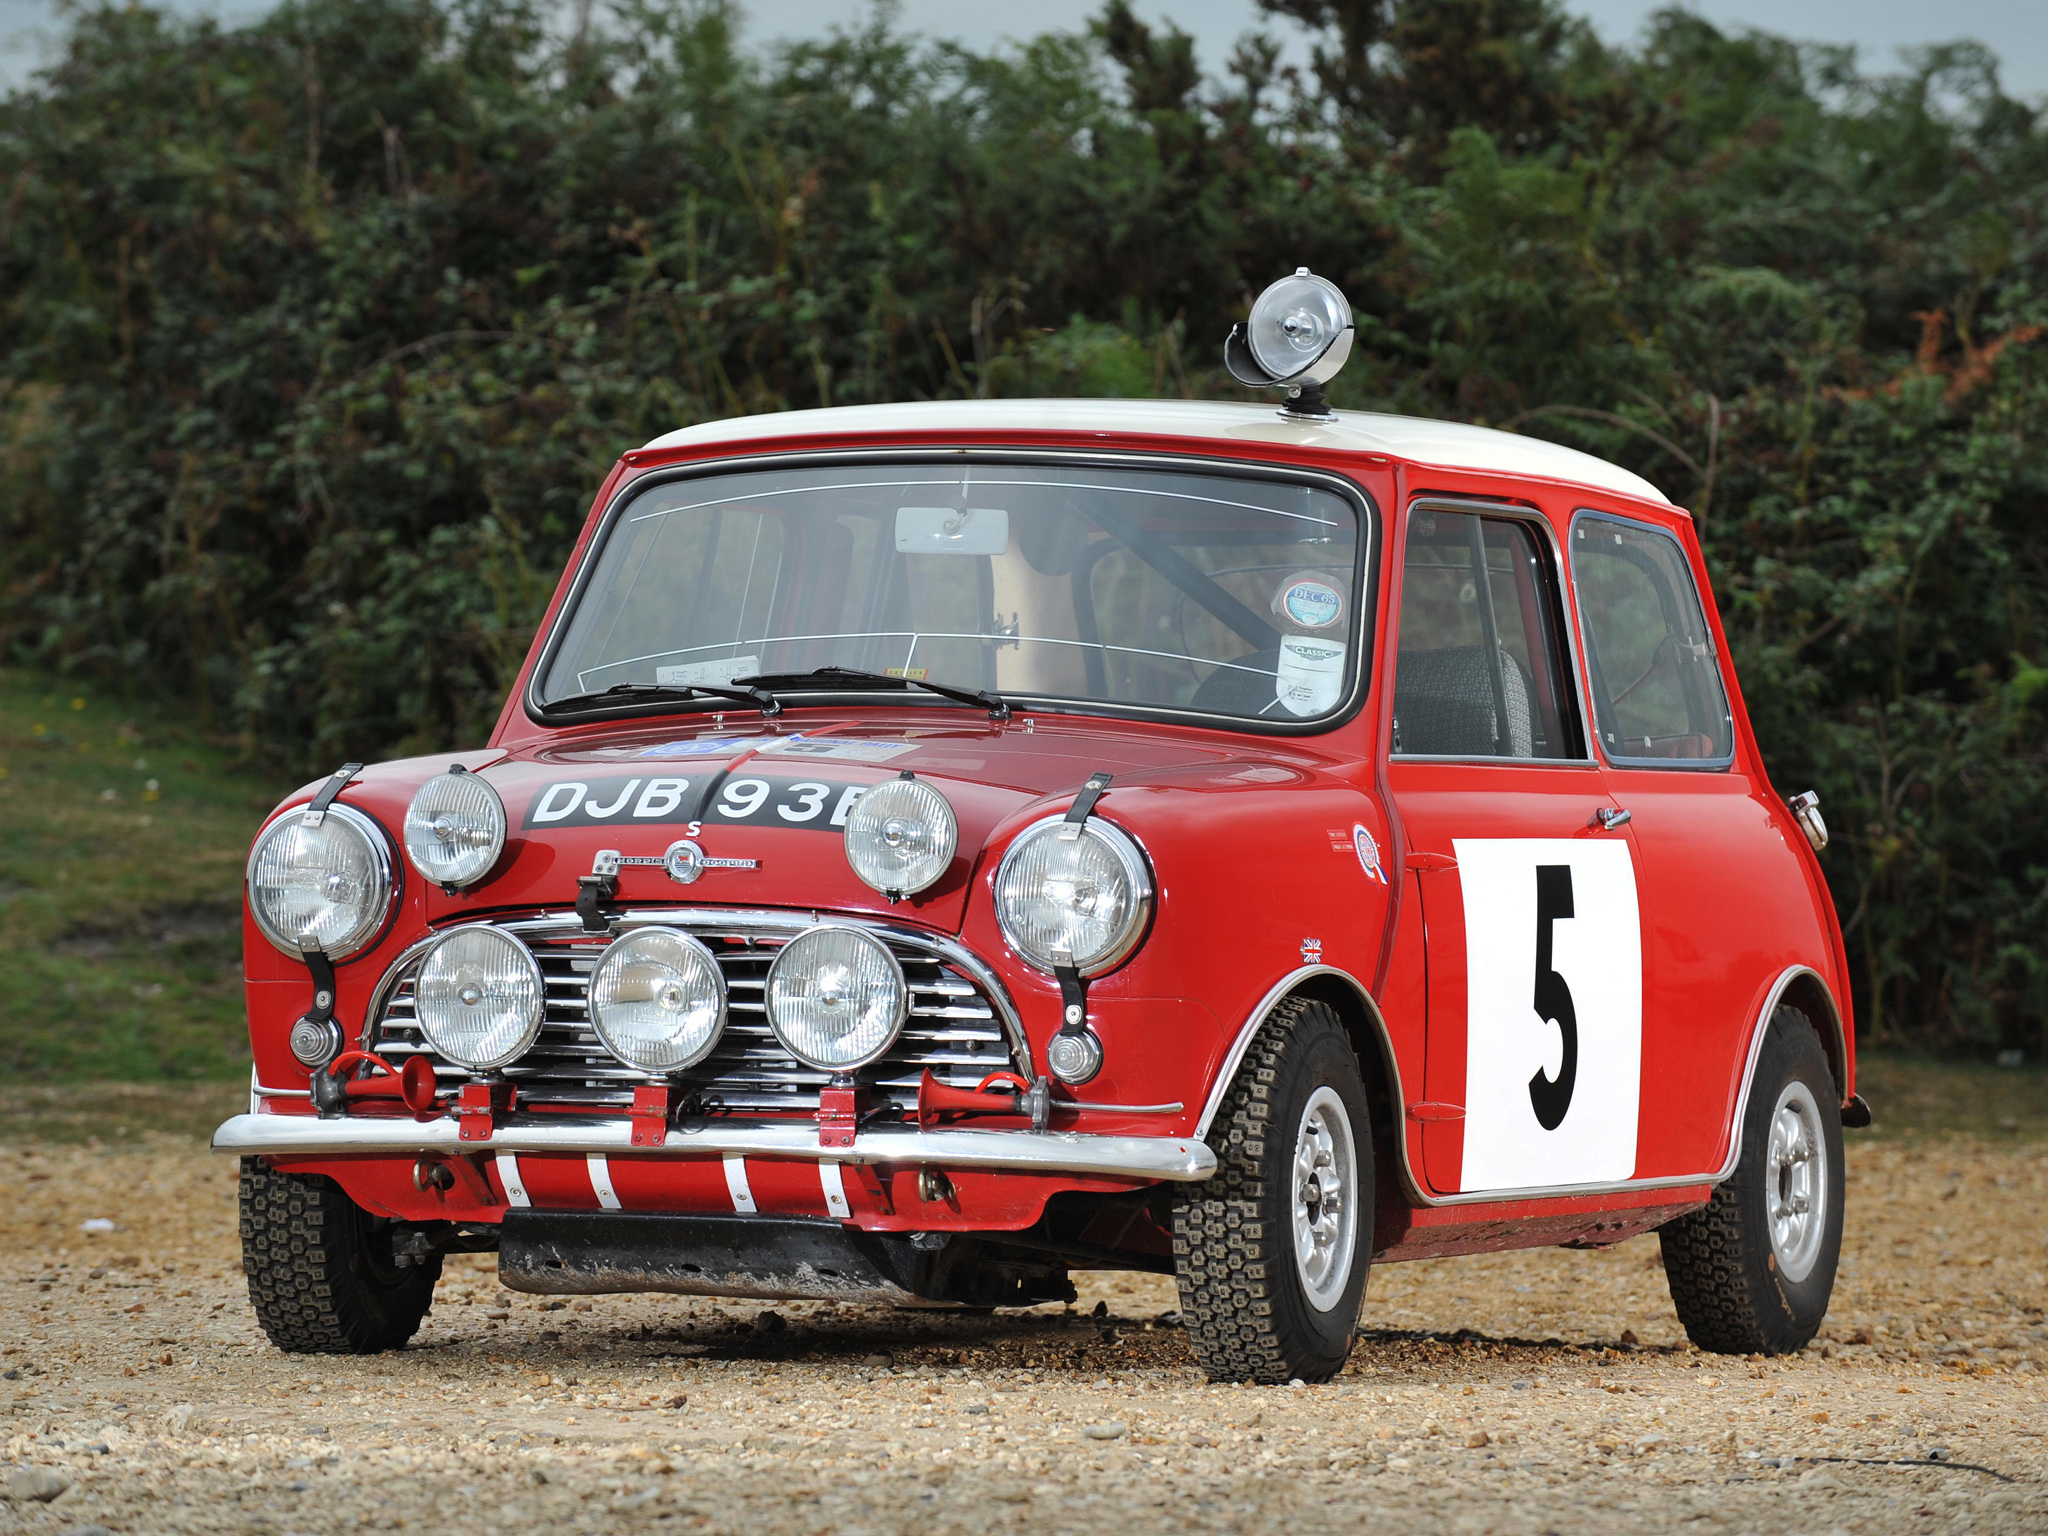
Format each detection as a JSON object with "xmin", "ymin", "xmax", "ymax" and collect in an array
[{"xmin": 1659, "ymin": 1008, "xmax": 1843, "ymax": 1354}]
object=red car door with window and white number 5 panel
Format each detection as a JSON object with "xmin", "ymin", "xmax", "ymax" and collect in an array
[{"xmin": 1389, "ymin": 500, "xmax": 1642, "ymax": 1196}]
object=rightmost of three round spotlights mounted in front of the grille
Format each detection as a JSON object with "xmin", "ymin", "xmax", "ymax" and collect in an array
[{"xmin": 768, "ymin": 924, "xmax": 909, "ymax": 1071}]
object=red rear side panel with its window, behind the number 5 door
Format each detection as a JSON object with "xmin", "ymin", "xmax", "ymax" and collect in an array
[{"xmin": 1569, "ymin": 512, "xmax": 1829, "ymax": 1178}]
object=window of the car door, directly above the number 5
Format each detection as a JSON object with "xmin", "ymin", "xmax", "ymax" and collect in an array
[{"xmin": 1393, "ymin": 506, "xmax": 1585, "ymax": 760}]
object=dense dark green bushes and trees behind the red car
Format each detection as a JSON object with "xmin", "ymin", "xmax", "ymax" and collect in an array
[{"xmin": 0, "ymin": 0, "xmax": 2048, "ymax": 1051}]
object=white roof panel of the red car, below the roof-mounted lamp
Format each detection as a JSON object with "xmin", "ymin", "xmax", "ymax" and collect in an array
[{"xmin": 647, "ymin": 399, "xmax": 1667, "ymax": 502}]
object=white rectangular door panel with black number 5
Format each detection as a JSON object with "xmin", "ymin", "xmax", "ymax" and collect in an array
[{"xmin": 1452, "ymin": 838, "xmax": 1642, "ymax": 1190}]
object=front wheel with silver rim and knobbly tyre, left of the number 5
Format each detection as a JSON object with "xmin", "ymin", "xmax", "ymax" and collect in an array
[{"xmin": 1174, "ymin": 997, "xmax": 1374, "ymax": 1384}]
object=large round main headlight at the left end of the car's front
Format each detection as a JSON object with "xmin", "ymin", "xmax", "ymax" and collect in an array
[{"xmin": 248, "ymin": 805, "xmax": 393, "ymax": 961}]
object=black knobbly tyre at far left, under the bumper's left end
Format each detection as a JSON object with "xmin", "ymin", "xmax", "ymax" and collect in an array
[{"xmin": 242, "ymin": 1157, "xmax": 440, "ymax": 1354}]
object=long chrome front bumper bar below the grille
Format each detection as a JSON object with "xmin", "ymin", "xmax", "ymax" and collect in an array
[{"xmin": 213, "ymin": 1114, "xmax": 1217, "ymax": 1184}]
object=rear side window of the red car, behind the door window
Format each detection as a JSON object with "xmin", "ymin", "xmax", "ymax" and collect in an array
[{"xmin": 1571, "ymin": 516, "xmax": 1735, "ymax": 766}]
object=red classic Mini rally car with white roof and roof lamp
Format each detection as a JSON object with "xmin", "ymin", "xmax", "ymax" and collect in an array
[{"xmin": 215, "ymin": 272, "xmax": 1868, "ymax": 1382}]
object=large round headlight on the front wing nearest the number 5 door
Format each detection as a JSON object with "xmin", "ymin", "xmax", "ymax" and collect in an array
[{"xmin": 995, "ymin": 815, "xmax": 1153, "ymax": 977}]
